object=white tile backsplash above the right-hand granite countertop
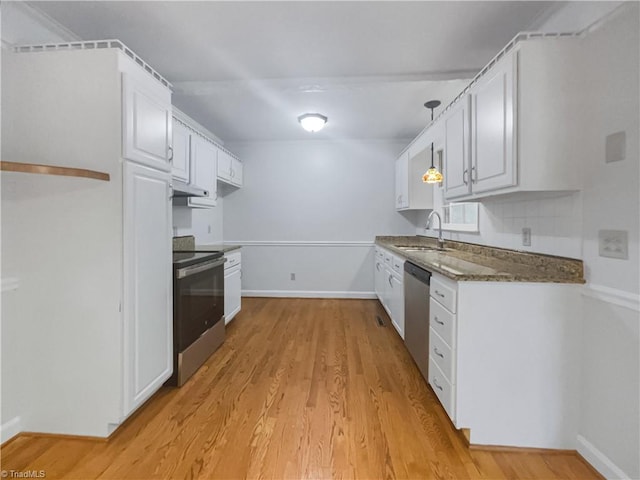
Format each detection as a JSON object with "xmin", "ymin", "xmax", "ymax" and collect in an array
[{"xmin": 418, "ymin": 192, "xmax": 582, "ymax": 258}]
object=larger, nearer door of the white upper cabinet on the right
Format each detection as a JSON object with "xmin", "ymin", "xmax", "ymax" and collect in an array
[{"xmin": 471, "ymin": 55, "xmax": 517, "ymax": 193}]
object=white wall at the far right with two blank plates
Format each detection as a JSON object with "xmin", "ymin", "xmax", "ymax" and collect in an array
[{"xmin": 579, "ymin": 2, "xmax": 640, "ymax": 478}]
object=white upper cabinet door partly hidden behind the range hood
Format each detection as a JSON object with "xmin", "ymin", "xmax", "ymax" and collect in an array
[{"xmin": 187, "ymin": 135, "xmax": 218, "ymax": 208}]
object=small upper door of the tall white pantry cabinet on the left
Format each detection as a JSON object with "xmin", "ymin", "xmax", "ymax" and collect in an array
[{"xmin": 122, "ymin": 73, "xmax": 173, "ymax": 171}]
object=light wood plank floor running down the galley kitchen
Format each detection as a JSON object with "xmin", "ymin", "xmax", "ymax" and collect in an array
[{"xmin": 1, "ymin": 298, "xmax": 599, "ymax": 480}]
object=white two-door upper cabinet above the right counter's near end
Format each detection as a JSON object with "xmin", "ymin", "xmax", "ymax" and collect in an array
[{"xmin": 430, "ymin": 36, "xmax": 587, "ymax": 201}]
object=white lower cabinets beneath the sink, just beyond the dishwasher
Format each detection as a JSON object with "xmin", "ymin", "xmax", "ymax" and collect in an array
[{"xmin": 374, "ymin": 247, "xmax": 404, "ymax": 339}]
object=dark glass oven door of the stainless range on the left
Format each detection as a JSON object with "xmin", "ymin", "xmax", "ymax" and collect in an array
[{"xmin": 173, "ymin": 257, "xmax": 225, "ymax": 353}]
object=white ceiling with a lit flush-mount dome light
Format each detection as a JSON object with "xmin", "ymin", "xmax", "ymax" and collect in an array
[{"xmin": 30, "ymin": 1, "xmax": 566, "ymax": 141}]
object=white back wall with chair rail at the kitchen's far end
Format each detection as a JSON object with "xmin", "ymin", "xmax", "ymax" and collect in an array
[{"xmin": 224, "ymin": 140, "xmax": 415, "ymax": 297}]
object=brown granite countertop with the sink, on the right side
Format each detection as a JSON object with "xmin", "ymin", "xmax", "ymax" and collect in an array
[{"xmin": 375, "ymin": 236, "xmax": 585, "ymax": 283}]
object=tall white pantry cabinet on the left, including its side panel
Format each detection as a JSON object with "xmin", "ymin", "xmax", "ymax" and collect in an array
[{"xmin": 2, "ymin": 42, "xmax": 173, "ymax": 437}]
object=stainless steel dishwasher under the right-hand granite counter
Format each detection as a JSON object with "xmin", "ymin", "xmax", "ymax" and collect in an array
[{"xmin": 404, "ymin": 262, "xmax": 431, "ymax": 381}]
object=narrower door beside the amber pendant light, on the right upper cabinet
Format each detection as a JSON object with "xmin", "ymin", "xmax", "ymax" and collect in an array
[{"xmin": 443, "ymin": 96, "xmax": 471, "ymax": 198}]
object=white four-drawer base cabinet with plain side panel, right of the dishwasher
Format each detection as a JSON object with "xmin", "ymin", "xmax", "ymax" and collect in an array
[{"xmin": 429, "ymin": 273, "xmax": 580, "ymax": 449}]
